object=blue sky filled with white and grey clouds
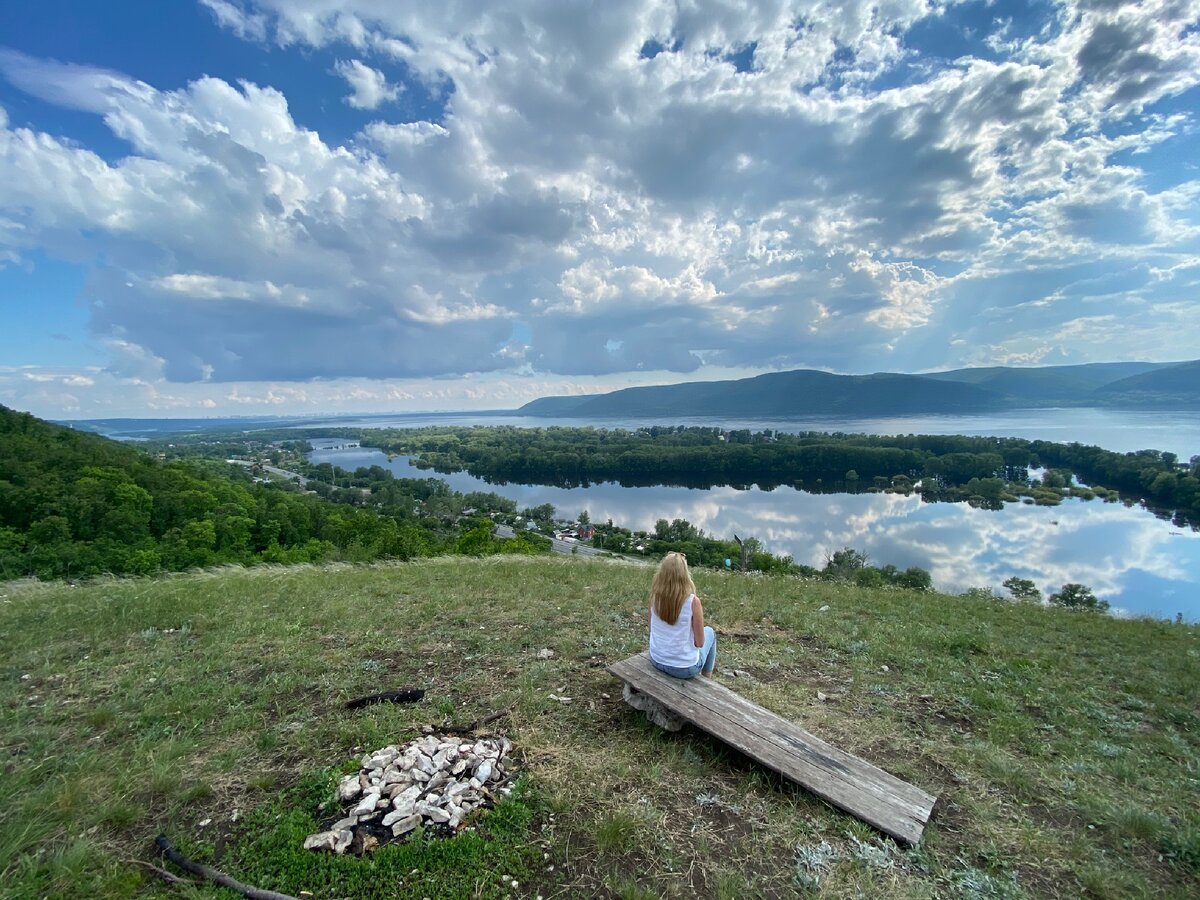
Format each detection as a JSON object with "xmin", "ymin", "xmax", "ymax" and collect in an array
[{"xmin": 0, "ymin": 0, "xmax": 1200, "ymax": 419}]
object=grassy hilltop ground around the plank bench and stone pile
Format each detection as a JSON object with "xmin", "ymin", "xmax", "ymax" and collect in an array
[{"xmin": 0, "ymin": 557, "xmax": 1200, "ymax": 898}]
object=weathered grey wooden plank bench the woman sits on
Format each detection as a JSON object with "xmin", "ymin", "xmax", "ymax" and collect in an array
[{"xmin": 608, "ymin": 652, "xmax": 937, "ymax": 845}]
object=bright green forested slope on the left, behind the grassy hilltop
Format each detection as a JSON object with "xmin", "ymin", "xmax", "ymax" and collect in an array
[{"xmin": 0, "ymin": 407, "xmax": 544, "ymax": 578}]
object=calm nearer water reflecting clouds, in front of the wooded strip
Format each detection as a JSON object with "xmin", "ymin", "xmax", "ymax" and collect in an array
[{"xmin": 310, "ymin": 446, "xmax": 1200, "ymax": 620}]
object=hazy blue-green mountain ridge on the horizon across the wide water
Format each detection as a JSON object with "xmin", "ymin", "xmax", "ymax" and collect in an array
[{"xmin": 517, "ymin": 360, "xmax": 1200, "ymax": 419}]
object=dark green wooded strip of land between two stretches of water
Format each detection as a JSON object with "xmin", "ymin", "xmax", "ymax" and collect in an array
[{"xmin": 354, "ymin": 426, "xmax": 1200, "ymax": 524}]
